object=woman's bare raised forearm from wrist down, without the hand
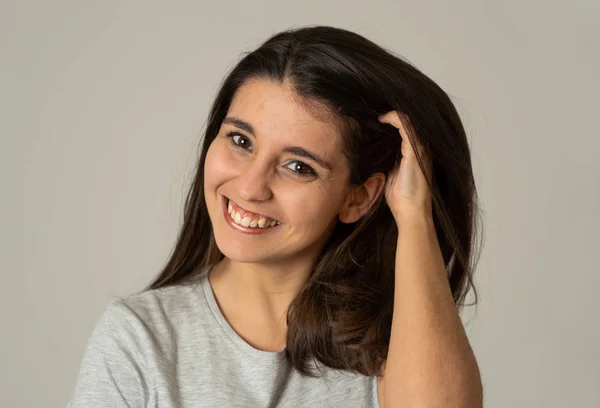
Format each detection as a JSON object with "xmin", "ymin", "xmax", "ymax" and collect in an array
[{"xmin": 384, "ymin": 217, "xmax": 482, "ymax": 408}]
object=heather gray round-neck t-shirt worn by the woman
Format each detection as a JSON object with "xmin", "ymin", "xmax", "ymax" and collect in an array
[{"xmin": 68, "ymin": 274, "xmax": 379, "ymax": 408}]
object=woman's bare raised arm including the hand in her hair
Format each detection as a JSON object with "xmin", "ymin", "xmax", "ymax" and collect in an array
[{"xmin": 379, "ymin": 111, "xmax": 483, "ymax": 408}]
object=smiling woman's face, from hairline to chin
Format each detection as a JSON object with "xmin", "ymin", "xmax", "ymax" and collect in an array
[{"xmin": 204, "ymin": 79, "xmax": 349, "ymax": 263}]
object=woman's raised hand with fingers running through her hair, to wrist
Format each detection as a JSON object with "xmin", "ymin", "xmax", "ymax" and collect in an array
[{"xmin": 379, "ymin": 111, "xmax": 432, "ymax": 223}]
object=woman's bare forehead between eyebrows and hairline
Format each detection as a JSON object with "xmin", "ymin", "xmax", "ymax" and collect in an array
[{"xmin": 228, "ymin": 79, "xmax": 341, "ymax": 155}]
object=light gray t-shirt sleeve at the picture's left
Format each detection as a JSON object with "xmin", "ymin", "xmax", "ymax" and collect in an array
[{"xmin": 68, "ymin": 299, "xmax": 148, "ymax": 408}]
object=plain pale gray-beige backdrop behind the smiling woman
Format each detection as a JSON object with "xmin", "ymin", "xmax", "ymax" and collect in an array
[{"xmin": 0, "ymin": 0, "xmax": 600, "ymax": 408}]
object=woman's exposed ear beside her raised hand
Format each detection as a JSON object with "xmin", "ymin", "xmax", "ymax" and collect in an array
[{"xmin": 339, "ymin": 173, "xmax": 386, "ymax": 224}]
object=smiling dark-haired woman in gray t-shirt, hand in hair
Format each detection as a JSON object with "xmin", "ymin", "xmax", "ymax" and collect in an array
[{"xmin": 70, "ymin": 27, "xmax": 482, "ymax": 408}]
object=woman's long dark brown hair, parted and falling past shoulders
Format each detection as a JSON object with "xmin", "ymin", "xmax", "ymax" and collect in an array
[{"xmin": 147, "ymin": 26, "xmax": 479, "ymax": 376}]
